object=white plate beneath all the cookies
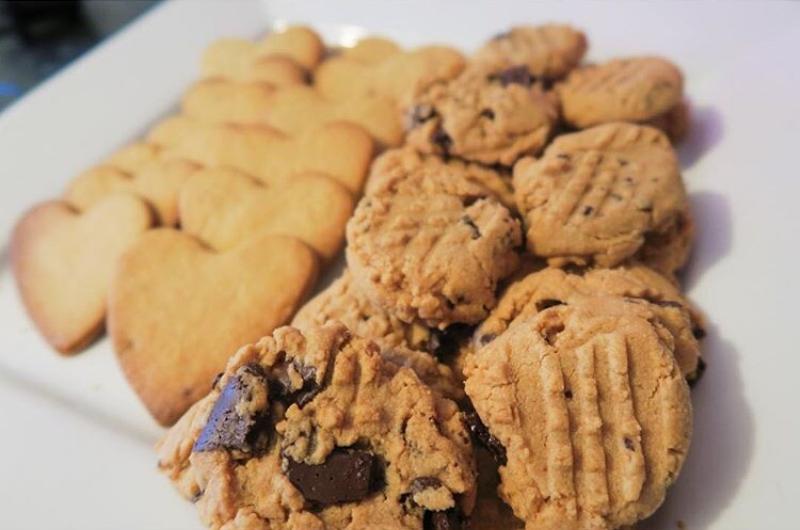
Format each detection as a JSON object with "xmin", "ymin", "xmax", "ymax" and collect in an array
[{"xmin": 0, "ymin": 0, "xmax": 800, "ymax": 530}]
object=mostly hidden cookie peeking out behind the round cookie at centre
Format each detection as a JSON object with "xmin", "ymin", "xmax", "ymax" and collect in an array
[{"xmin": 365, "ymin": 147, "xmax": 517, "ymax": 210}]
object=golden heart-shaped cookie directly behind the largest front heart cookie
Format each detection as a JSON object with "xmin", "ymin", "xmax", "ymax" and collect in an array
[{"xmin": 179, "ymin": 168, "xmax": 354, "ymax": 260}]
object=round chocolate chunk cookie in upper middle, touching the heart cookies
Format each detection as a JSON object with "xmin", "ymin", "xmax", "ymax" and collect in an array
[{"xmin": 407, "ymin": 66, "xmax": 558, "ymax": 166}]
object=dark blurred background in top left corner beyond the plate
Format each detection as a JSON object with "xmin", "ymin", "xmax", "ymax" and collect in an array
[{"xmin": 0, "ymin": 0, "xmax": 160, "ymax": 111}]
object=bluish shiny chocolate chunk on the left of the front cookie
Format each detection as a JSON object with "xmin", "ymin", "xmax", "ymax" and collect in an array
[{"xmin": 192, "ymin": 363, "xmax": 270, "ymax": 455}]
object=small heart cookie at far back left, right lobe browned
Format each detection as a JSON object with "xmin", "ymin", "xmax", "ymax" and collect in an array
[{"xmin": 200, "ymin": 38, "xmax": 308, "ymax": 86}]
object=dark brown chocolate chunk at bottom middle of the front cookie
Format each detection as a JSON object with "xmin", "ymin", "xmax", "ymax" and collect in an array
[{"xmin": 284, "ymin": 449, "xmax": 380, "ymax": 506}]
